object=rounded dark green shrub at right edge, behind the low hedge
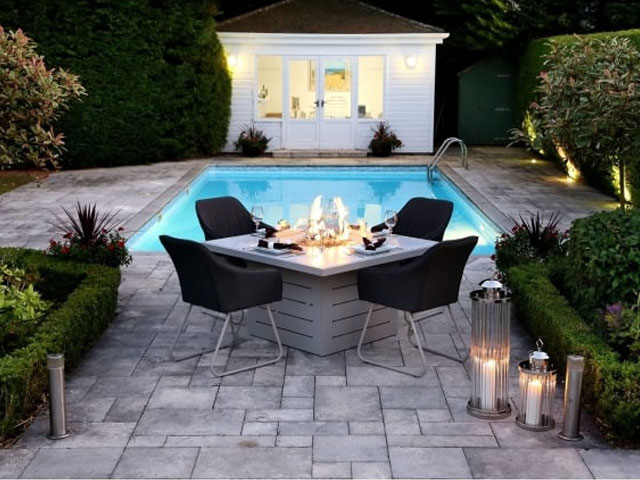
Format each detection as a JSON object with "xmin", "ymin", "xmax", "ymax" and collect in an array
[{"xmin": 562, "ymin": 209, "xmax": 640, "ymax": 318}]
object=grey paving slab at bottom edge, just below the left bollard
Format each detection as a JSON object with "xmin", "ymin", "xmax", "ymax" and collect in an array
[{"xmin": 22, "ymin": 448, "xmax": 122, "ymax": 478}]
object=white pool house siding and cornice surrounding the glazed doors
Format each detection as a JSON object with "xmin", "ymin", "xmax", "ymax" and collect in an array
[{"xmin": 220, "ymin": 33, "xmax": 446, "ymax": 153}]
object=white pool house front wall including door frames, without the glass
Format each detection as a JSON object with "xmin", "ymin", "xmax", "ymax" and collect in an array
[{"xmin": 219, "ymin": 32, "xmax": 448, "ymax": 153}]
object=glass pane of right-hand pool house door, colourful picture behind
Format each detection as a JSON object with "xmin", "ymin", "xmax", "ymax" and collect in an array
[{"xmin": 323, "ymin": 60, "xmax": 351, "ymax": 118}]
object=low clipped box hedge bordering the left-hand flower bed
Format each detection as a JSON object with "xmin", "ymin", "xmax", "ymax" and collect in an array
[{"xmin": 0, "ymin": 248, "xmax": 120, "ymax": 435}]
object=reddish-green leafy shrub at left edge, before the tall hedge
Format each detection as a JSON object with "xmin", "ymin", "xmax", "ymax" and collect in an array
[{"xmin": 0, "ymin": 25, "xmax": 86, "ymax": 168}]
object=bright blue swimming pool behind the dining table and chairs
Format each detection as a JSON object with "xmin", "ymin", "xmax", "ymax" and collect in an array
[{"xmin": 127, "ymin": 166, "xmax": 500, "ymax": 255}]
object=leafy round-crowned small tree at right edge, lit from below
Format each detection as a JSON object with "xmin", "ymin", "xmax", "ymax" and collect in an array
[{"xmin": 533, "ymin": 36, "xmax": 640, "ymax": 206}]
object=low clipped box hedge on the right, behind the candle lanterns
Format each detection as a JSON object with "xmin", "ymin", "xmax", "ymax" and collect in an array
[{"xmin": 508, "ymin": 264, "xmax": 640, "ymax": 445}]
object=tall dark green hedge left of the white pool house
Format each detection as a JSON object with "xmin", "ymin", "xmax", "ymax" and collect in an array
[{"xmin": 0, "ymin": 0, "xmax": 231, "ymax": 167}]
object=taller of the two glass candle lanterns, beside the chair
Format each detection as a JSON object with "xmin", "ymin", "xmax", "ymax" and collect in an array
[{"xmin": 467, "ymin": 280, "xmax": 511, "ymax": 419}]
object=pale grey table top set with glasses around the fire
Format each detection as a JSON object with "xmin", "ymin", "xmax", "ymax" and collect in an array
[{"xmin": 204, "ymin": 235, "xmax": 437, "ymax": 277}]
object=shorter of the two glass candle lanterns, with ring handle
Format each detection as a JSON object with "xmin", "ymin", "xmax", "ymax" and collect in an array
[{"xmin": 516, "ymin": 339, "xmax": 556, "ymax": 431}]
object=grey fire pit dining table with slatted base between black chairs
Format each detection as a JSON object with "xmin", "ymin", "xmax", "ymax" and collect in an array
[{"xmin": 205, "ymin": 234, "xmax": 437, "ymax": 356}]
